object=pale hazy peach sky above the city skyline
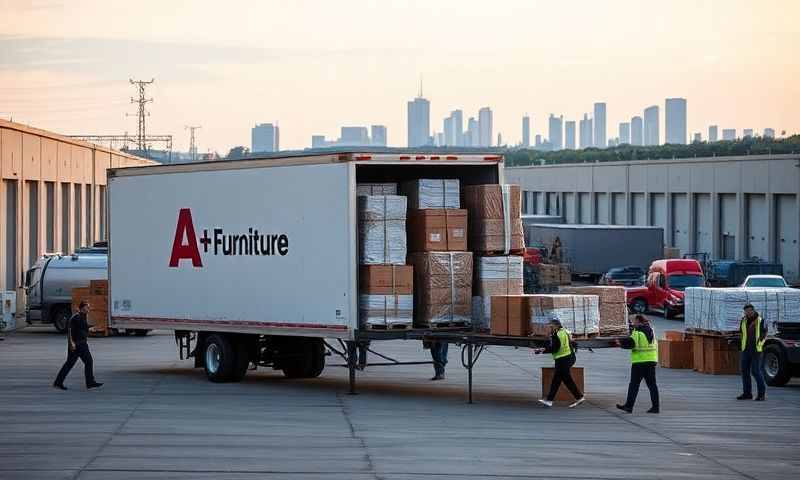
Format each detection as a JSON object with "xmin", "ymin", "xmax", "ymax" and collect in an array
[{"xmin": 0, "ymin": 0, "xmax": 800, "ymax": 154}]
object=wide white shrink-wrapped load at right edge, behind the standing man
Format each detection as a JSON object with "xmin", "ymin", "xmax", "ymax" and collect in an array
[{"xmin": 684, "ymin": 287, "xmax": 800, "ymax": 333}]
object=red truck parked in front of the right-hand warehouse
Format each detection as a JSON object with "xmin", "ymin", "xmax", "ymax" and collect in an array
[{"xmin": 626, "ymin": 259, "xmax": 706, "ymax": 318}]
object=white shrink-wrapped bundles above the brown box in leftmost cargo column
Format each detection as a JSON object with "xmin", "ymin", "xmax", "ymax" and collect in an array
[{"xmin": 358, "ymin": 195, "xmax": 407, "ymax": 265}]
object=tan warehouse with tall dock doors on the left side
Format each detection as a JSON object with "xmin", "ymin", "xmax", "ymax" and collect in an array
[{"xmin": 0, "ymin": 120, "xmax": 153, "ymax": 311}]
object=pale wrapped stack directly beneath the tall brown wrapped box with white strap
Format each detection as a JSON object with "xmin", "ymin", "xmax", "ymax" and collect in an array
[{"xmin": 472, "ymin": 256, "xmax": 524, "ymax": 330}]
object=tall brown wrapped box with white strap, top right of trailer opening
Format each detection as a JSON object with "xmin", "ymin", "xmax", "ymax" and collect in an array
[{"xmin": 464, "ymin": 184, "xmax": 525, "ymax": 255}]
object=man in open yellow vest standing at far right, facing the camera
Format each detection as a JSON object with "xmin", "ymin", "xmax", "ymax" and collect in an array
[{"xmin": 736, "ymin": 303, "xmax": 767, "ymax": 402}]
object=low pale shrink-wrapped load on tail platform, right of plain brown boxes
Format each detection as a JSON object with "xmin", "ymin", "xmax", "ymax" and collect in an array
[{"xmin": 528, "ymin": 295, "xmax": 600, "ymax": 337}]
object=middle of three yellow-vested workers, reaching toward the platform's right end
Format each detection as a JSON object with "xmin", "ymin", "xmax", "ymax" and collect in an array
[{"xmin": 617, "ymin": 315, "xmax": 661, "ymax": 413}]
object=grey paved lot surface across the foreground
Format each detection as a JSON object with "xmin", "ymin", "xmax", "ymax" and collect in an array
[{"xmin": 0, "ymin": 320, "xmax": 800, "ymax": 480}]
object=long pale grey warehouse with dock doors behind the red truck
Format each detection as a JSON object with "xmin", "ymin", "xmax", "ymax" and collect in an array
[{"xmin": 506, "ymin": 154, "xmax": 800, "ymax": 283}]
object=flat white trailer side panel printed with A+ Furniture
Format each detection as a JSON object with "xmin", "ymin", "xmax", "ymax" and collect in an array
[{"xmin": 109, "ymin": 163, "xmax": 358, "ymax": 338}]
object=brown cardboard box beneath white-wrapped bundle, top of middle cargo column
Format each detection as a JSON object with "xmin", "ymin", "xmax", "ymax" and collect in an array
[{"xmin": 407, "ymin": 208, "xmax": 467, "ymax": 252}]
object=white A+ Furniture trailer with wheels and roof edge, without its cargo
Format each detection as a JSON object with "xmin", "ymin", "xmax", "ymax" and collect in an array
[{"xmin": 108, "ymin": 152, "xmax": 503, "ymax": 387}]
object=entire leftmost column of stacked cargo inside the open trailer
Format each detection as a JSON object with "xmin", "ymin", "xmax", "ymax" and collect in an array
[{"xmin": 357, "ymin": 188, "xmax": 414, "ymax": 329}]
